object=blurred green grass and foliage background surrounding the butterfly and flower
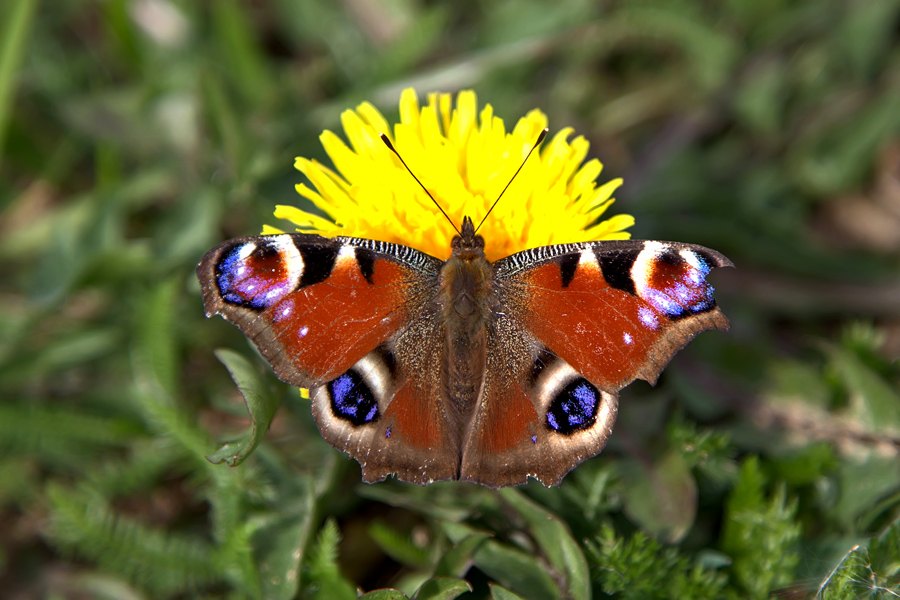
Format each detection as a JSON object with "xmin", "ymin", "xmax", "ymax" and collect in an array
[{"xmin": 0, "ymin": 0, "xmax": 900, "ymax": 599}]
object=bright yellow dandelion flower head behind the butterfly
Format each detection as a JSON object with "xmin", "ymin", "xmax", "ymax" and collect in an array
[{"xmin": 265, "ymin": 89, "xmax": 634, "ymax": 260}]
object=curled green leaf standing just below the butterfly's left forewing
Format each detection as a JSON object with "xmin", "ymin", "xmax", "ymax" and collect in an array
[{"xmin": 206, "ymin": 348, "xmax": 279, "ymax": 467}]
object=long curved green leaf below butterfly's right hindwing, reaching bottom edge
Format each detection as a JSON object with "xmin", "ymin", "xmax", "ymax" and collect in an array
[{"xmin": 500, "ymin": 488, "xmax": 591, "ymax": 600}]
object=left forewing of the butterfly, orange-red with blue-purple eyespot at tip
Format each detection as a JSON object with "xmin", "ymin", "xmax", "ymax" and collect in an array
[{"xmin": 197, "ymin": 234, "xmax": 440, "ymax": 388}]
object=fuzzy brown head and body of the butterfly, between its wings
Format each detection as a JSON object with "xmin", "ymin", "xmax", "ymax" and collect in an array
[{"xmin": 438, "ymin": 217, "xmax": 497, "ymax": 426}]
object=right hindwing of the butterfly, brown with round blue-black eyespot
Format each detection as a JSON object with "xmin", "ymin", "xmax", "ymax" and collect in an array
[{"xmin": 461, "ymin": 324, "xmax": 618, "ymax": 488}]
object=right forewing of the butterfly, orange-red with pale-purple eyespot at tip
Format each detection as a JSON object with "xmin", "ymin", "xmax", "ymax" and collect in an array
[{"xmin": 495, "ymin": 240, "xmax": 732, "ymax": 392}]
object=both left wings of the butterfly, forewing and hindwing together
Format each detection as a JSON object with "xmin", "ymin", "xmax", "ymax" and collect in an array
[{"xmin": 197, "ymin": 234, "xmax": 459, "ymax": 483}]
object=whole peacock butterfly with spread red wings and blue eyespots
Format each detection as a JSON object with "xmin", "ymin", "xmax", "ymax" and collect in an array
[{"xmin": 197, "ymin": 132, "xmax": 732, "ymax": 488}]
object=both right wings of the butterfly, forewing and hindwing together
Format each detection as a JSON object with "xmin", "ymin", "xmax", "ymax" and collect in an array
[{"xmin": 461, "ymin": 240, "xmax": 731, "ymax": 487}]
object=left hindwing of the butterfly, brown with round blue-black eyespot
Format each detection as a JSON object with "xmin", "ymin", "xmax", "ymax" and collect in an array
[{"xmin": 310, "ymin": 316, "xmax": 459, "ymax": 485}]
